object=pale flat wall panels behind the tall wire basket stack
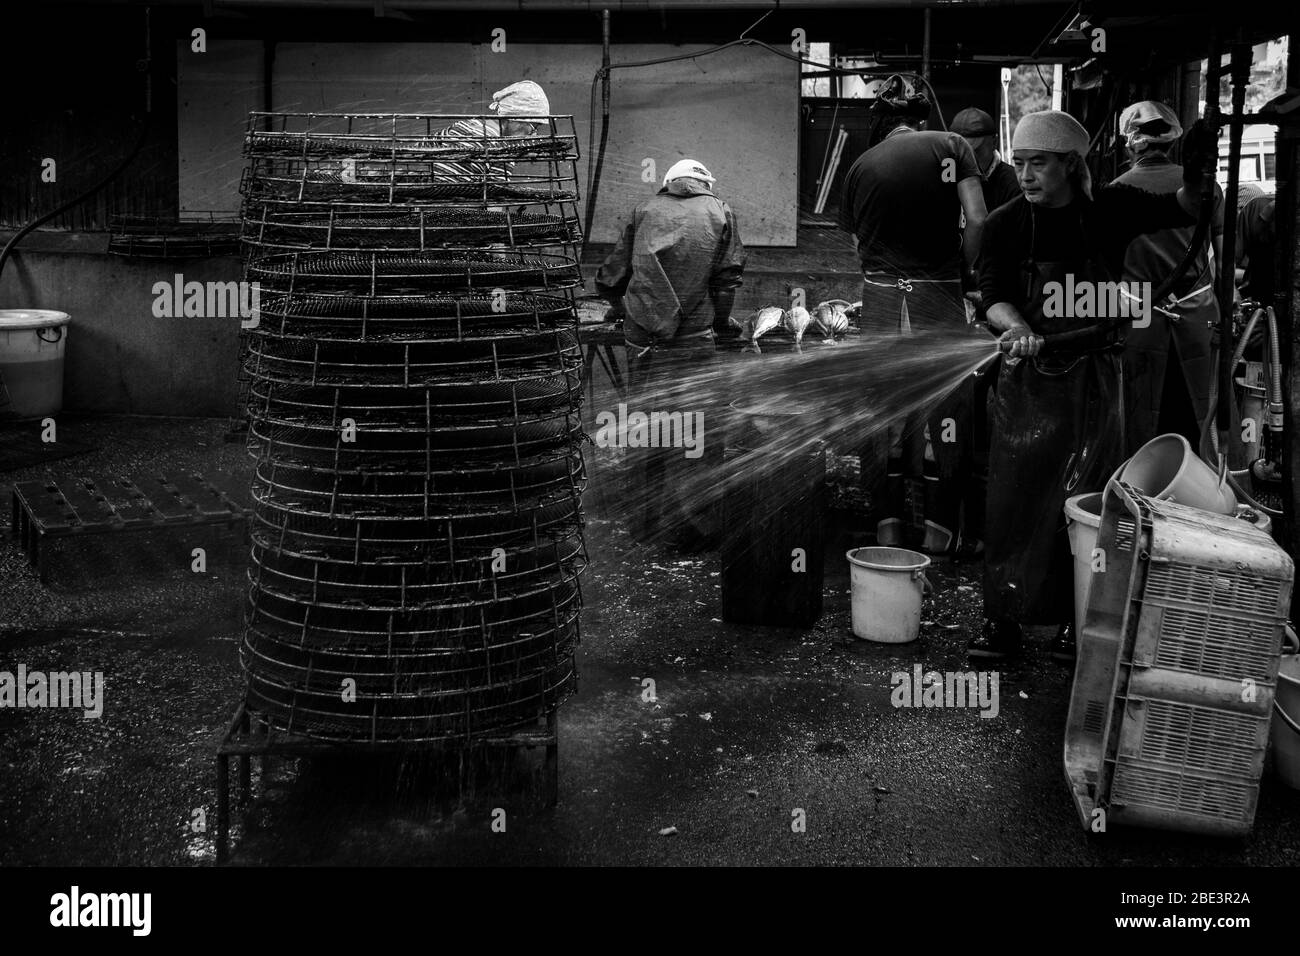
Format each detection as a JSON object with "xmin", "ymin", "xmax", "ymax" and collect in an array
[{"xmin": 178, "ymin": 42, "xmax": 800, "ymax": 246}]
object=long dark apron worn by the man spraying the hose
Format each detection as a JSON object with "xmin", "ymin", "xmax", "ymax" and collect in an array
[{"xmin": 984, "ymin": 254, "xmax": 1123, "ymax": 624}]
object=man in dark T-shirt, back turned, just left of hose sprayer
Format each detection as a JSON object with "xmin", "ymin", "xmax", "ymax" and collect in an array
[{"xmin": 840, "ymin": 77, "xmax": 984, "ymax": 553}]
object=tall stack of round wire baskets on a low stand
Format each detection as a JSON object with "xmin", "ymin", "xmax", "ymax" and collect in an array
[{"xmin": 241, "ymin": 113, "xmax": 586, "ymax": 743}]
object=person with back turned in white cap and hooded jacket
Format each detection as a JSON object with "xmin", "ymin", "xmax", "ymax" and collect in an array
[{"xmin": 595, "ymin": 159, "xmax": 745, "ymax": 550}]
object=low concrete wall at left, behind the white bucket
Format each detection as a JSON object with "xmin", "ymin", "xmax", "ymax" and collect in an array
[{"xmin": 0, "ymin": 234, "xmax": 241, "ymax": 416}]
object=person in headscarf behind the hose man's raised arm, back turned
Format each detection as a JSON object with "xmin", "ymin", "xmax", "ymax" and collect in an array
[{"xmin": 1115, "ymin": 100, "xmax": 1223, "ymax": 455}]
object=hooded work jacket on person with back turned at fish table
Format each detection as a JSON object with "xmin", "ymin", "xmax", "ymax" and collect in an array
[{"xmin": 595, "ymin": 179, "xmax": 745, "ymax": 346}]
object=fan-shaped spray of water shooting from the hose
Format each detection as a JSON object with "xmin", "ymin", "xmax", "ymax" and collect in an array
[{"xmin": 595, "ymin": 330, "xmax": 996, "ymax": 554}]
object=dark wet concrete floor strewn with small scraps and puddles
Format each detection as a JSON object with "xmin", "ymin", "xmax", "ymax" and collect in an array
[{"xmin": 0, "ymin": 419, "xmax": 1300, "ymax": 865}]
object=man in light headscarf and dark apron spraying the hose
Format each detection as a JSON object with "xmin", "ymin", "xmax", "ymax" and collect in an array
[{"xmin": 970, "ymin": 109, "xmax": 1217, "ymax": 658}]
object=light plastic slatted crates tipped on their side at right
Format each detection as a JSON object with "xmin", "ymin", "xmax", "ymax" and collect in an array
[{"xmin": 1065, "ymin": 480, "xmax": 1295, "ymax": 836}]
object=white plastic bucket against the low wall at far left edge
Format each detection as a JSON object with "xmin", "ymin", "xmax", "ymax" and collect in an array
[{"xmin": 0, "ymin": 308, "xmax": 70, "ymax": 418}]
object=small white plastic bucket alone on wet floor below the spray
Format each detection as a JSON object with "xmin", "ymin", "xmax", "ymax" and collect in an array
[{"xmin": 846, "ymin": 548, "xmax": 930, "ymax": 644}]
